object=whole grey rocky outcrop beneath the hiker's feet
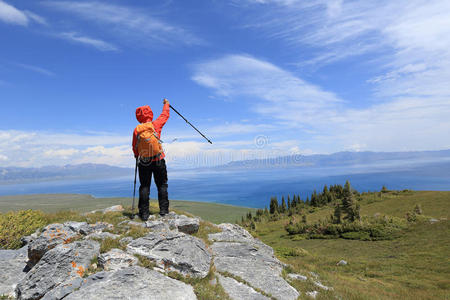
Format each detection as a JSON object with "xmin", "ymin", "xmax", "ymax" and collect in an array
[{"xmin": 0, "ymin": 213, "xmax": 306, "ymax": 300}]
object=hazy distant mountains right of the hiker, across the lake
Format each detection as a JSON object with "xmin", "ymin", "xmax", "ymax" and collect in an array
[{"xmin": 214, "ymin": 150, "xmax": 450, "ymax": 169}]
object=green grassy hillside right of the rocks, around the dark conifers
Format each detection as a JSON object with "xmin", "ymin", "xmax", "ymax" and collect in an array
[{"xmin": 253, "ymin": 191, "xmax": 450, "ymax": 299}]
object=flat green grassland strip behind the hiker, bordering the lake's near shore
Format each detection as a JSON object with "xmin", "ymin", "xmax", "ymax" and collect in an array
[{"xmin": 0, "ymin": 194, "xmax": 254, "ymax": 223}]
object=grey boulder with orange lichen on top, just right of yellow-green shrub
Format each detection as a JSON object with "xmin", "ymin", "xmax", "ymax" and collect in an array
[{"xmin": 28, "ymin": 224, "xmax": 78, "ymax": 267}]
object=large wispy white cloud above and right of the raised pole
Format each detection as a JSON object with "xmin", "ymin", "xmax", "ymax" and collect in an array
[{"xmin": 192, "ymin": 55, "xmax": 342, "ymax": 129}]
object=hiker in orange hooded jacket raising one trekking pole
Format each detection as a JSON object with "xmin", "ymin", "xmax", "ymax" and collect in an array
[{"xmin": 133, "ymin": 99, "xmax": 170, "ymax": 221}]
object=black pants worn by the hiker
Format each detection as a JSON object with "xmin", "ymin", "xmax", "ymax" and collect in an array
[{"xmin": 138, "ymin": 159, "xmax": 169, "ymax": 215}]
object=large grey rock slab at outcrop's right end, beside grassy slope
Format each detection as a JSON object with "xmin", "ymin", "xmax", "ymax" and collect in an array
[{"xmin": 209, "ymin": 224, "xmax": 300, "ymax": 299}]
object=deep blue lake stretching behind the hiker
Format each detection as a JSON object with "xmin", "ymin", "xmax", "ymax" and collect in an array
[{"xmin": 0, "ymin": 163, "xmax": 450, "ymax": 207}]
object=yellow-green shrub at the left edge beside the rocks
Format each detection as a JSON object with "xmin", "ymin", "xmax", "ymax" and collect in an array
[{"xmin": 0, "ymin": 209, "xmax": 47, "ymax": 249}]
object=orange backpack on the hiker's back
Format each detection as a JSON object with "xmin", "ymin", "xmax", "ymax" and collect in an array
[{"xmin": 135, "ymin": 122, "xmax": 163, "ymax": 159}]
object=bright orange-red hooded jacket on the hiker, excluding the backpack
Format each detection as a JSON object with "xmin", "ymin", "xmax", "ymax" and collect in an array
[{"xmin": 132, "ymin": 103, "xmax": 170, "ymax": 161}]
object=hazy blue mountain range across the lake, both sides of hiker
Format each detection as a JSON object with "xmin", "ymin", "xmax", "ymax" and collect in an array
[{"xmin": 0, "ymin": 150, "xmax": 450, "ymax": 184}]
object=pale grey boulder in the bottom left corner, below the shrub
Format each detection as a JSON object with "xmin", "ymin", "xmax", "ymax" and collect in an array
[{"xmin": 0, "ymin": 247, "xmax": 27, "ymax": 297}]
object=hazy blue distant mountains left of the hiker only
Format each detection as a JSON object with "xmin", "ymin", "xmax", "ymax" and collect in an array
[{"xmin": 0, "ymin": 164, "xmax": 133, "ymax": 184}]
